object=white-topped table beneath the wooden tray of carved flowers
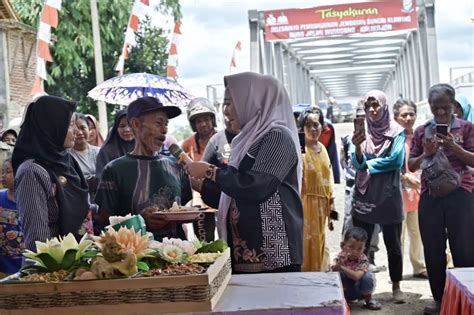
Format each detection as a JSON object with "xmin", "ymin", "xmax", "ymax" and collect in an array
[{"xmin": 0, "ymin": 272, "xmax": 350, "ymax": 315}]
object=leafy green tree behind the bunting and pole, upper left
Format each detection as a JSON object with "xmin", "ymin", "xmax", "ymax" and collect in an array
[{"xmin": 12, "ymin": 0, "xmax": 181, "ymax": 123}]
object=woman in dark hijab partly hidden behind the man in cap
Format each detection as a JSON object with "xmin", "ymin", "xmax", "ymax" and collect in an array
[{"xmin": 95, "ymin": 110, "xmax": 135, "ymax": 180}]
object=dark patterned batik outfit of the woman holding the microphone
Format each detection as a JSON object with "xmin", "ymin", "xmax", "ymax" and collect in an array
[{"xmin": 202, "ymin": 128, "xmax": 303, "ymax": 273}]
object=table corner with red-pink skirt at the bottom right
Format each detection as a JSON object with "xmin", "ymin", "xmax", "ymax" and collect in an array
[{"xmin": 441, "ymin": 268, "xmax": 474, "ymax": 315}]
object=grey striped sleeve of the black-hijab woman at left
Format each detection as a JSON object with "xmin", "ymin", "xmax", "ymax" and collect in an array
[{"xmin": 15, "ymin": 160, "xmax": 59, "ymax": 251}]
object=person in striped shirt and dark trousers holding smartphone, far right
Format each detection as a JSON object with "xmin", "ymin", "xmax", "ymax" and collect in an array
[{"xmin": 408, "ymin": 84, "xmax": 474, "ymax": 314}]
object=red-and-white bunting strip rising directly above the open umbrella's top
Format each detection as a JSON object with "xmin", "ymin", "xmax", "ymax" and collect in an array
[{"xmin": 115, "ymin": 0, "xmax": 150, "ymax": 75}]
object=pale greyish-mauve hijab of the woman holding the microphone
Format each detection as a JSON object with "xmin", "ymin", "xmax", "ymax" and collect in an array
[{"xmin": 217, "ymin": 72, "xmax": 302, "ymax": 240}]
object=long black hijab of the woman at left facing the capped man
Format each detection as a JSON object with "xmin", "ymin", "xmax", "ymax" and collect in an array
[{"xmin": 12, "ymin": 96, "xmax": 90, "ymax": 237}]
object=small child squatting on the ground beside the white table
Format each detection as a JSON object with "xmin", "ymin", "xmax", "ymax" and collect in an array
[{"xmin": 332, "ymin": 227, "xmax": 382, "ymax": 310}]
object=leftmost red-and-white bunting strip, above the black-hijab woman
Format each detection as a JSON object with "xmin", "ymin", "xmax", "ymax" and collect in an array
[{"xmin": 30, "ymin": 0, "xmax": 61, "ymax": 98}]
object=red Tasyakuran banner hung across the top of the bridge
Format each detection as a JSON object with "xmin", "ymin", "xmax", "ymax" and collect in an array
[{"xmin": 263, "ymin": 0, "xmax": 417, "ymax": 41}]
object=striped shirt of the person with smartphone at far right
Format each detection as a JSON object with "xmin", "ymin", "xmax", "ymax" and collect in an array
[{"xmin": 410, "ymin": 118, "xmax": 474, "ymax": 193}]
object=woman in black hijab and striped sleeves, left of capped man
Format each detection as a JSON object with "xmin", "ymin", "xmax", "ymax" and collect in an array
[{"xmin": 12, "ymin": 96, "xmax": 90, "ymax": 250}]
